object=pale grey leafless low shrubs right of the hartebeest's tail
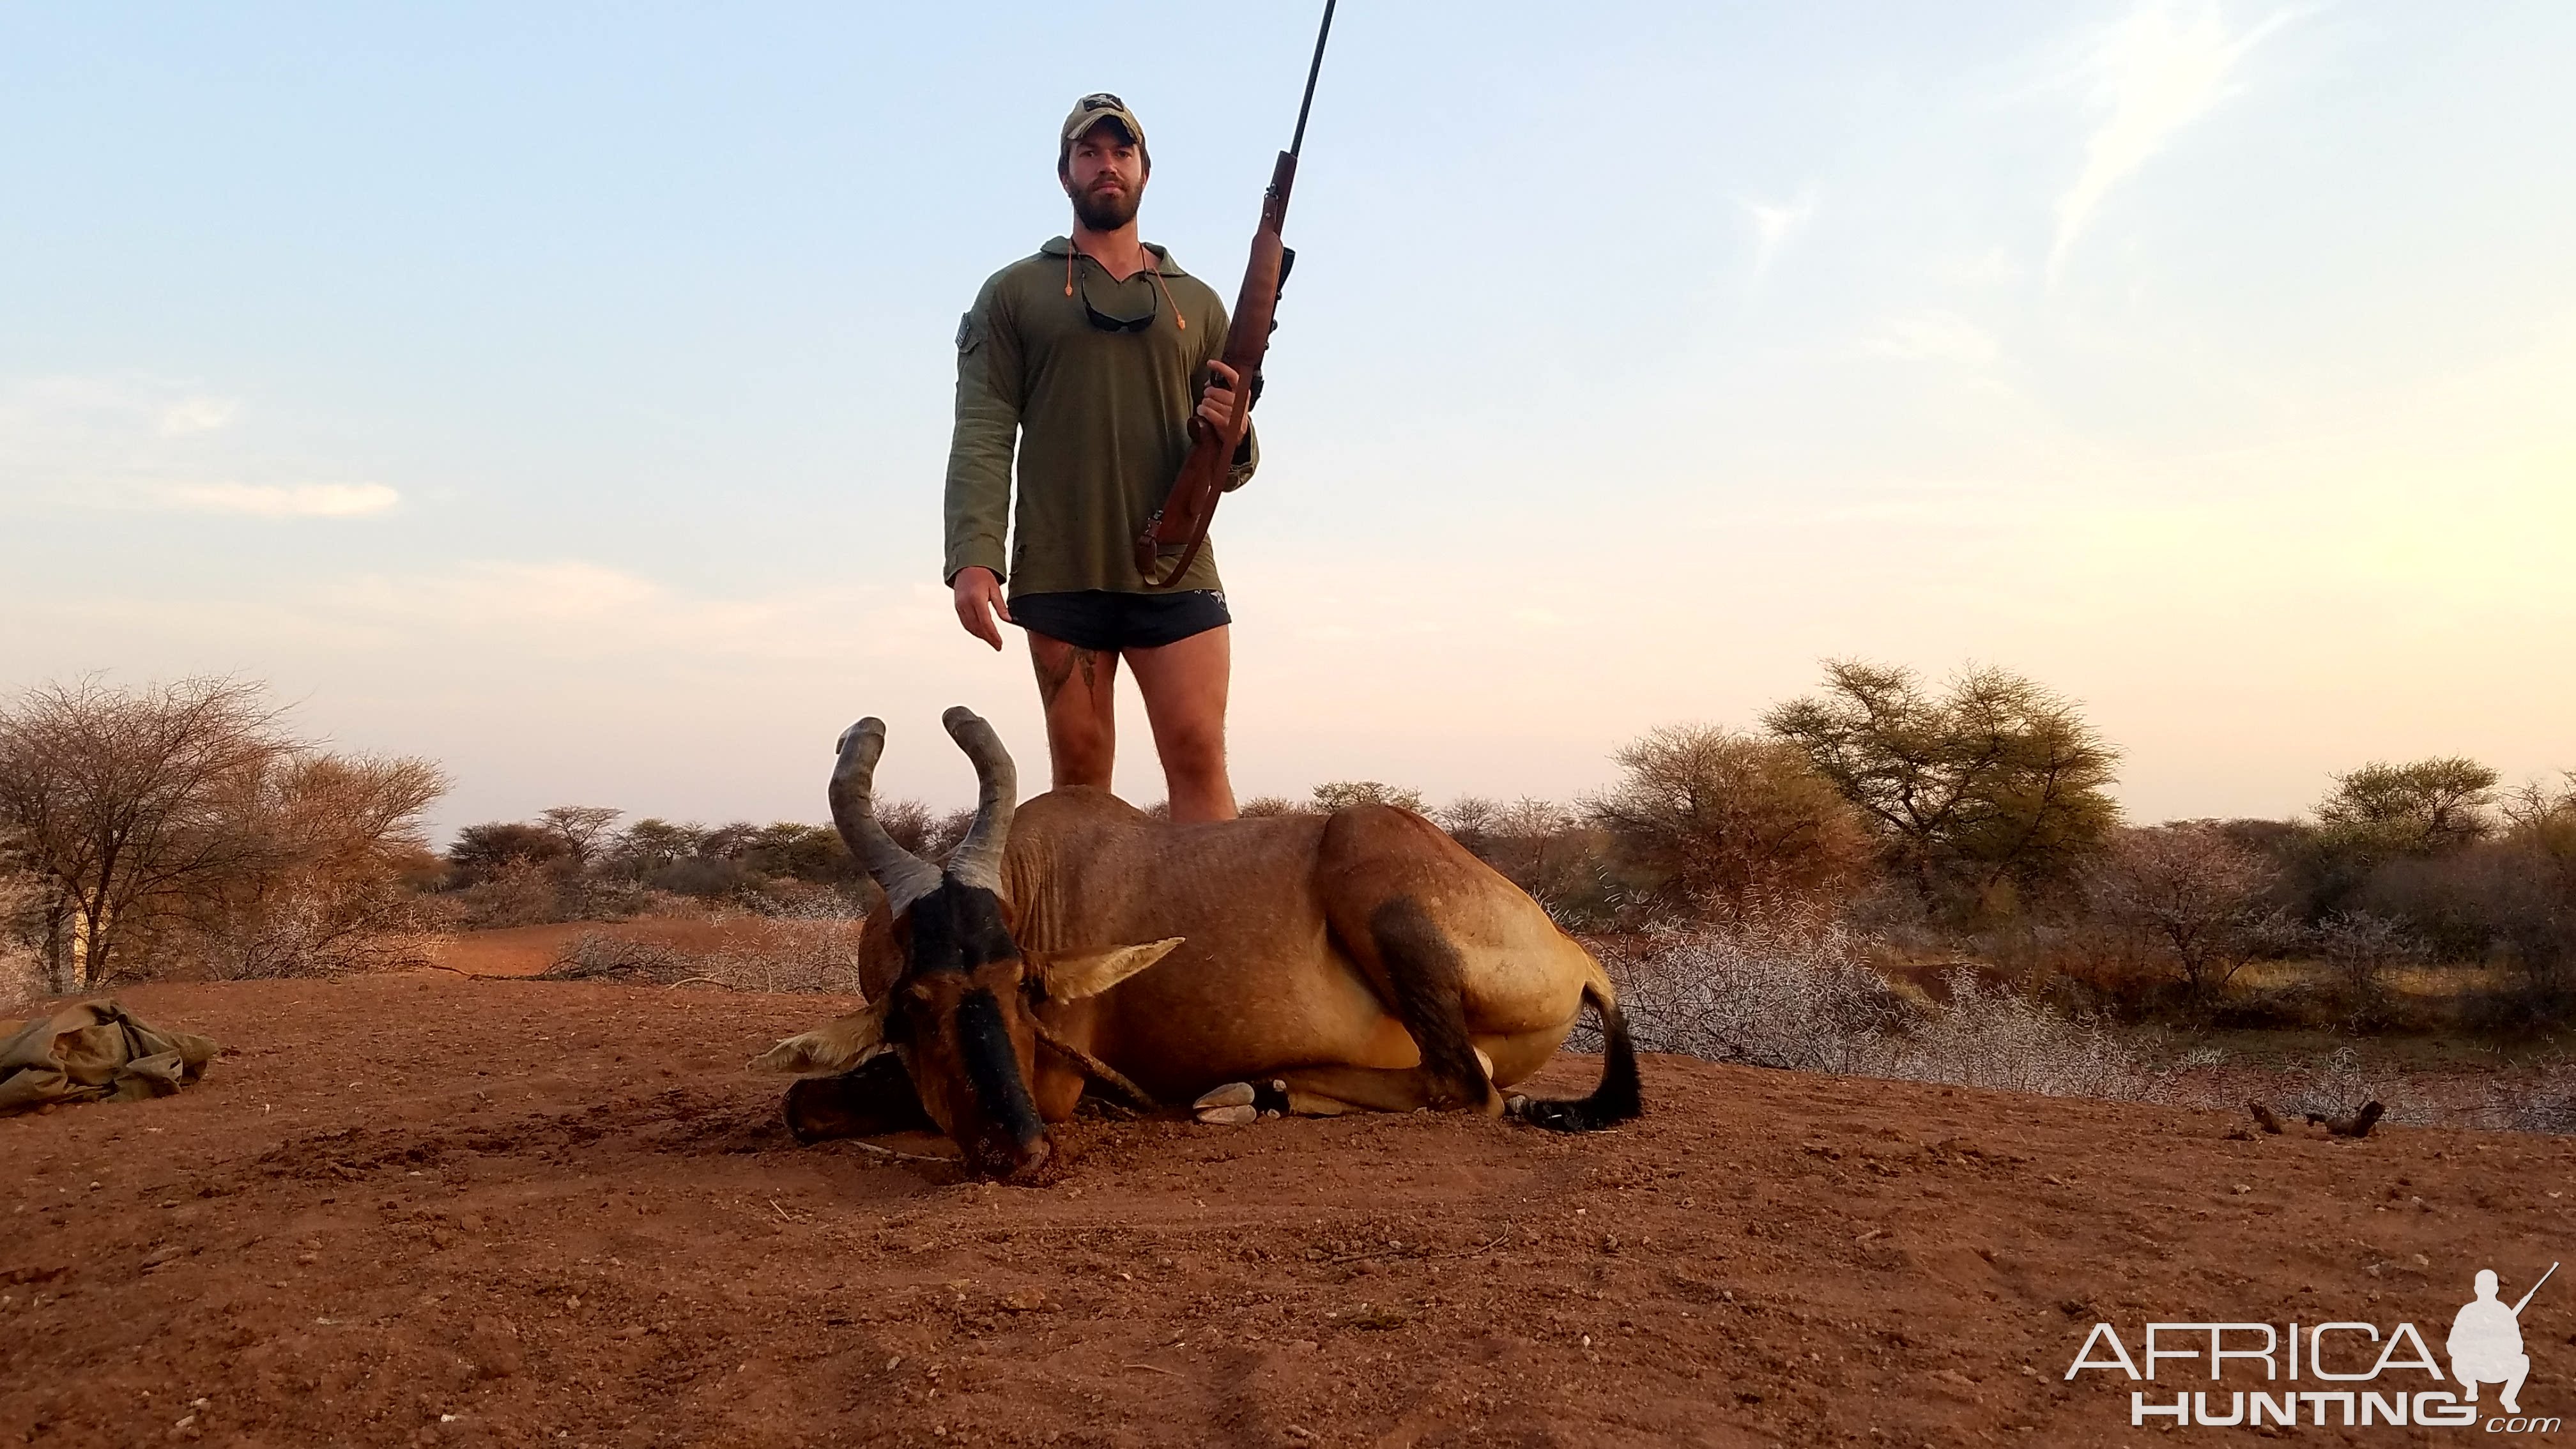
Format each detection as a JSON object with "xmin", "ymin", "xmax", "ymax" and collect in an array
[{"xmin": 1602, "ymin": 905, "xmax": 2200, "ymax": 1101}]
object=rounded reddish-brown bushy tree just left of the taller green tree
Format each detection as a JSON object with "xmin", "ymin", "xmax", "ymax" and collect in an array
[{"xmin": 1584, "ymin": 724, "xmax": 1870, "ymax": 921}]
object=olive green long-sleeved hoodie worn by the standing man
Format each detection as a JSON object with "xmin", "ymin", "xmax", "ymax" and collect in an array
[{"xmin": 946, "ymin": 237, "xmax": 1260, "ymax": 598}]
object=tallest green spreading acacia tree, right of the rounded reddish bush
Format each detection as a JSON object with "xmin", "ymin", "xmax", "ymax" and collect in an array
[{"xmin": 1762, "ymin": 660, "xmax": 2120, "ymax": 908}]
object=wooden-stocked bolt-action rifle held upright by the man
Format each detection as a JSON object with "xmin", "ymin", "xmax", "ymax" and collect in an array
[{"xmin": 1136, "ymin": 0, "xmax": 1335, "ymax": 588}]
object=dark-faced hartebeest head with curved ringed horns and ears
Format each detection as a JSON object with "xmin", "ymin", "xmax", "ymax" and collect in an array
[{"xmin": 760, "ymin": 707, "xmax": 1180, "ymax": 1178}]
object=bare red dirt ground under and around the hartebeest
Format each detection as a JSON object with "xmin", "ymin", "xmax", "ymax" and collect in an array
[{"xmin": 0, "ymin": 959, "xmax": 2576, "ymax": 1449}]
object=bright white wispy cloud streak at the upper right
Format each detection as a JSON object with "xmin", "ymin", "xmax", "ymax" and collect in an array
[{"xmin": 2048, "ymin": 0, "xmax": 2292, "ymax": 281}]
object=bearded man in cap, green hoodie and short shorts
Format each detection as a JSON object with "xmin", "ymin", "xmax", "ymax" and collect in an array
[{"xmin": 946, "ymin": 93, "xmax": 1260, "ymax": 820}]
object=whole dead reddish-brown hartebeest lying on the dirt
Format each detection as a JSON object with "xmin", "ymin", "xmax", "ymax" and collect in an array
[{"xmin": 762, "ymin": 709, "xmax": 1638, "ymax": 1176}]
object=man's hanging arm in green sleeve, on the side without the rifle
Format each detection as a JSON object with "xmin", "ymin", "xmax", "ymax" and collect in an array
[{"xmin": 943, "ymin": 281, "xmax": 1020, "ymax": 650}]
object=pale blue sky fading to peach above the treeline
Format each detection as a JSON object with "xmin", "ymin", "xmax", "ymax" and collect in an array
[{"xmin": 0, "ymin": 0, "xmax": 2576, "ymax": 830}]
